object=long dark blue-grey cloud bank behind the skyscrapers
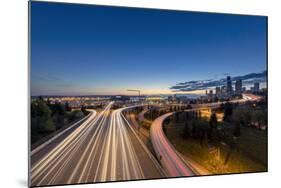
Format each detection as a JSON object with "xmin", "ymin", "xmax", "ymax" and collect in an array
[{"xmin": 170, "ymin": 71, "xmax": 266, "ymax": 92}]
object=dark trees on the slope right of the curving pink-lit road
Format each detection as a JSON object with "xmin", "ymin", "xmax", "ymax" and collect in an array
[{"xmin": 164, "ymin": 103, "xmax": 267, "ymax": 164}]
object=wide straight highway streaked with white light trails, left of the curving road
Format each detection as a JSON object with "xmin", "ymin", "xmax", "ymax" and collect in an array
[{"xmin": 31, "ymin": 102, "xmax": 164, "ymax": 186}]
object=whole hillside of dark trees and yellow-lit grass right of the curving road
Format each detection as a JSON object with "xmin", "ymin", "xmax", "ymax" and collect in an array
[{"xmin": 164, "ymin": 101, "xmax": 267, "ymax": 174}]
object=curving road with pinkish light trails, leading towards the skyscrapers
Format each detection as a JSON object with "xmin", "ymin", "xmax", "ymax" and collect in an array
[{"xmin": 150, "ymin": 95, "xmax": 261, "ymax": 177}]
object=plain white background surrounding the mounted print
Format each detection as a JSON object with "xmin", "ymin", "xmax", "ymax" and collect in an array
[{"xmin": 0, "ymin": 0, "xmax": 281, "ymax": 188}]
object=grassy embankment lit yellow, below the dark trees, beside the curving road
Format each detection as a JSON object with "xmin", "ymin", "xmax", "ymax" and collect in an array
[{"xmin": 165, "ymin": 111, "xmax": 267, "ymax": 174}]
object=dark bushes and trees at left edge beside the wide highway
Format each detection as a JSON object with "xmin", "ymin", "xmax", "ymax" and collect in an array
[{"xmin": 31, "ymin": 98, "xmax": 88, "ymax": 144}]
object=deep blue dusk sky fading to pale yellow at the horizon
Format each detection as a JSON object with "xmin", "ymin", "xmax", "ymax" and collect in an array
[{"xmin": 30, "ymin": 2, "xmax": 267, "ymax": 95}]
